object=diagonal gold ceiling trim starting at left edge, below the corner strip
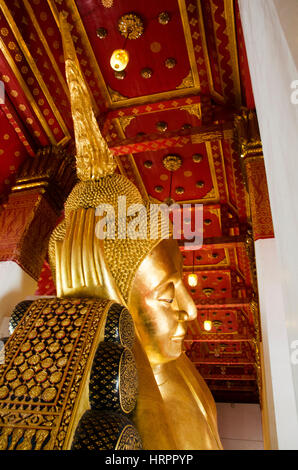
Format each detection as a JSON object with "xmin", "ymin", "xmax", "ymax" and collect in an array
[{"xmin": 0, "ymin": 37, "xmax": 57, "ymax": 145}]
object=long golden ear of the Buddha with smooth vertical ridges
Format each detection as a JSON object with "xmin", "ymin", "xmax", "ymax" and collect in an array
[{"xmin": 55, "ymin": 208, "xmax": 124, "ymax": 305}]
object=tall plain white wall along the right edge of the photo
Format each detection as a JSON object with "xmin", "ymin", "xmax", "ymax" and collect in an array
[{"xmin": 239, "ymin": 0, "xmax": 298, "ymax": 449}]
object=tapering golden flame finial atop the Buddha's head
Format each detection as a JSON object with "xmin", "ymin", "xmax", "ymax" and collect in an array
[{"xmin": 60, "ymin": 12, "xmax": 116, "ymax": 181}]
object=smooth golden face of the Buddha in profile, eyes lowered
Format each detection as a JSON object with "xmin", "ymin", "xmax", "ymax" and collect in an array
[{"xmin": 128, "ymin": 240, "xmax": 197, "ymax": 366}]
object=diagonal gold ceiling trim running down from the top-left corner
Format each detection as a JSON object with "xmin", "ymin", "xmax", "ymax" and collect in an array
[{"xmin": 0, "ymin": 0, "xmax": 69, "ymax": 136}]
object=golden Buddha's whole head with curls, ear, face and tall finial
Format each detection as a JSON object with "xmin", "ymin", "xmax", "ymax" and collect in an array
[{"xmin": 49, "ymin": 15, "xmax": 196, "ymax": 365}]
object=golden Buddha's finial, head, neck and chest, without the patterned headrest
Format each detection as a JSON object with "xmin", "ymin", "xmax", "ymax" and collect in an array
[{"xmin": 49, "ymin": 13, "xmax": 221, "ymax": 449}]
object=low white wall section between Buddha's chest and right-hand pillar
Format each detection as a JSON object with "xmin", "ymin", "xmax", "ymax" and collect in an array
[{"xmin": 216, "ymin": 403, "xmax": 264, "ymax": 450}]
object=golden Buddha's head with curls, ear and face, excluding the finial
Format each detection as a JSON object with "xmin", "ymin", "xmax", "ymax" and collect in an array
[{"xmin": 49, "ymin": 174, "xmax": 196, "ymax": 365}]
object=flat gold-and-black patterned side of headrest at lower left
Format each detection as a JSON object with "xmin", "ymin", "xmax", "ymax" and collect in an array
[{"xmin": 0, "ymin": 298, "xmax": 112, "ymax": 450}]
